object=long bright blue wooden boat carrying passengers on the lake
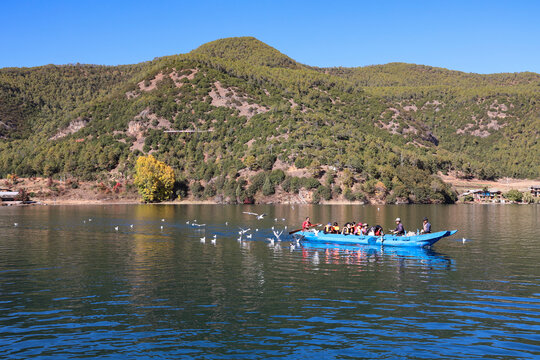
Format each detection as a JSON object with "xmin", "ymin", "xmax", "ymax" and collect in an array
[{"xmin": 297, "ymin": 230, "xmax": 457, "ymax": 247}]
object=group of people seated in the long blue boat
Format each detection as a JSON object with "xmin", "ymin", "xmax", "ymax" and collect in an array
[{"xmin": 302, "ymin": 217, "xmax": 431, "ymax": 236}]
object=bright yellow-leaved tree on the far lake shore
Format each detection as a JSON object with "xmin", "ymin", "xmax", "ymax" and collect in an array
[{"xmin": 135, "ymin": 155, "xmax": 174, "ymax": 202}]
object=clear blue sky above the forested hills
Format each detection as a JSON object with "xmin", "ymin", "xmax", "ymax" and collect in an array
[{"xmin": 0, "ymin": 0, "xmax": 540, "ymax": 73}]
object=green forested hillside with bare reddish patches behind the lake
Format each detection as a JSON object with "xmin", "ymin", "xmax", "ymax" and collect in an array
[{"xmin": 0, "ymin": 38, "xmax": 540, "ymax": 202}]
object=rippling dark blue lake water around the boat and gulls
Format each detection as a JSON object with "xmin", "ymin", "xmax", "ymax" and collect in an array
[{"xmin": 0, "ymin": 205, "xmax": 540, "ymax": 359}]
